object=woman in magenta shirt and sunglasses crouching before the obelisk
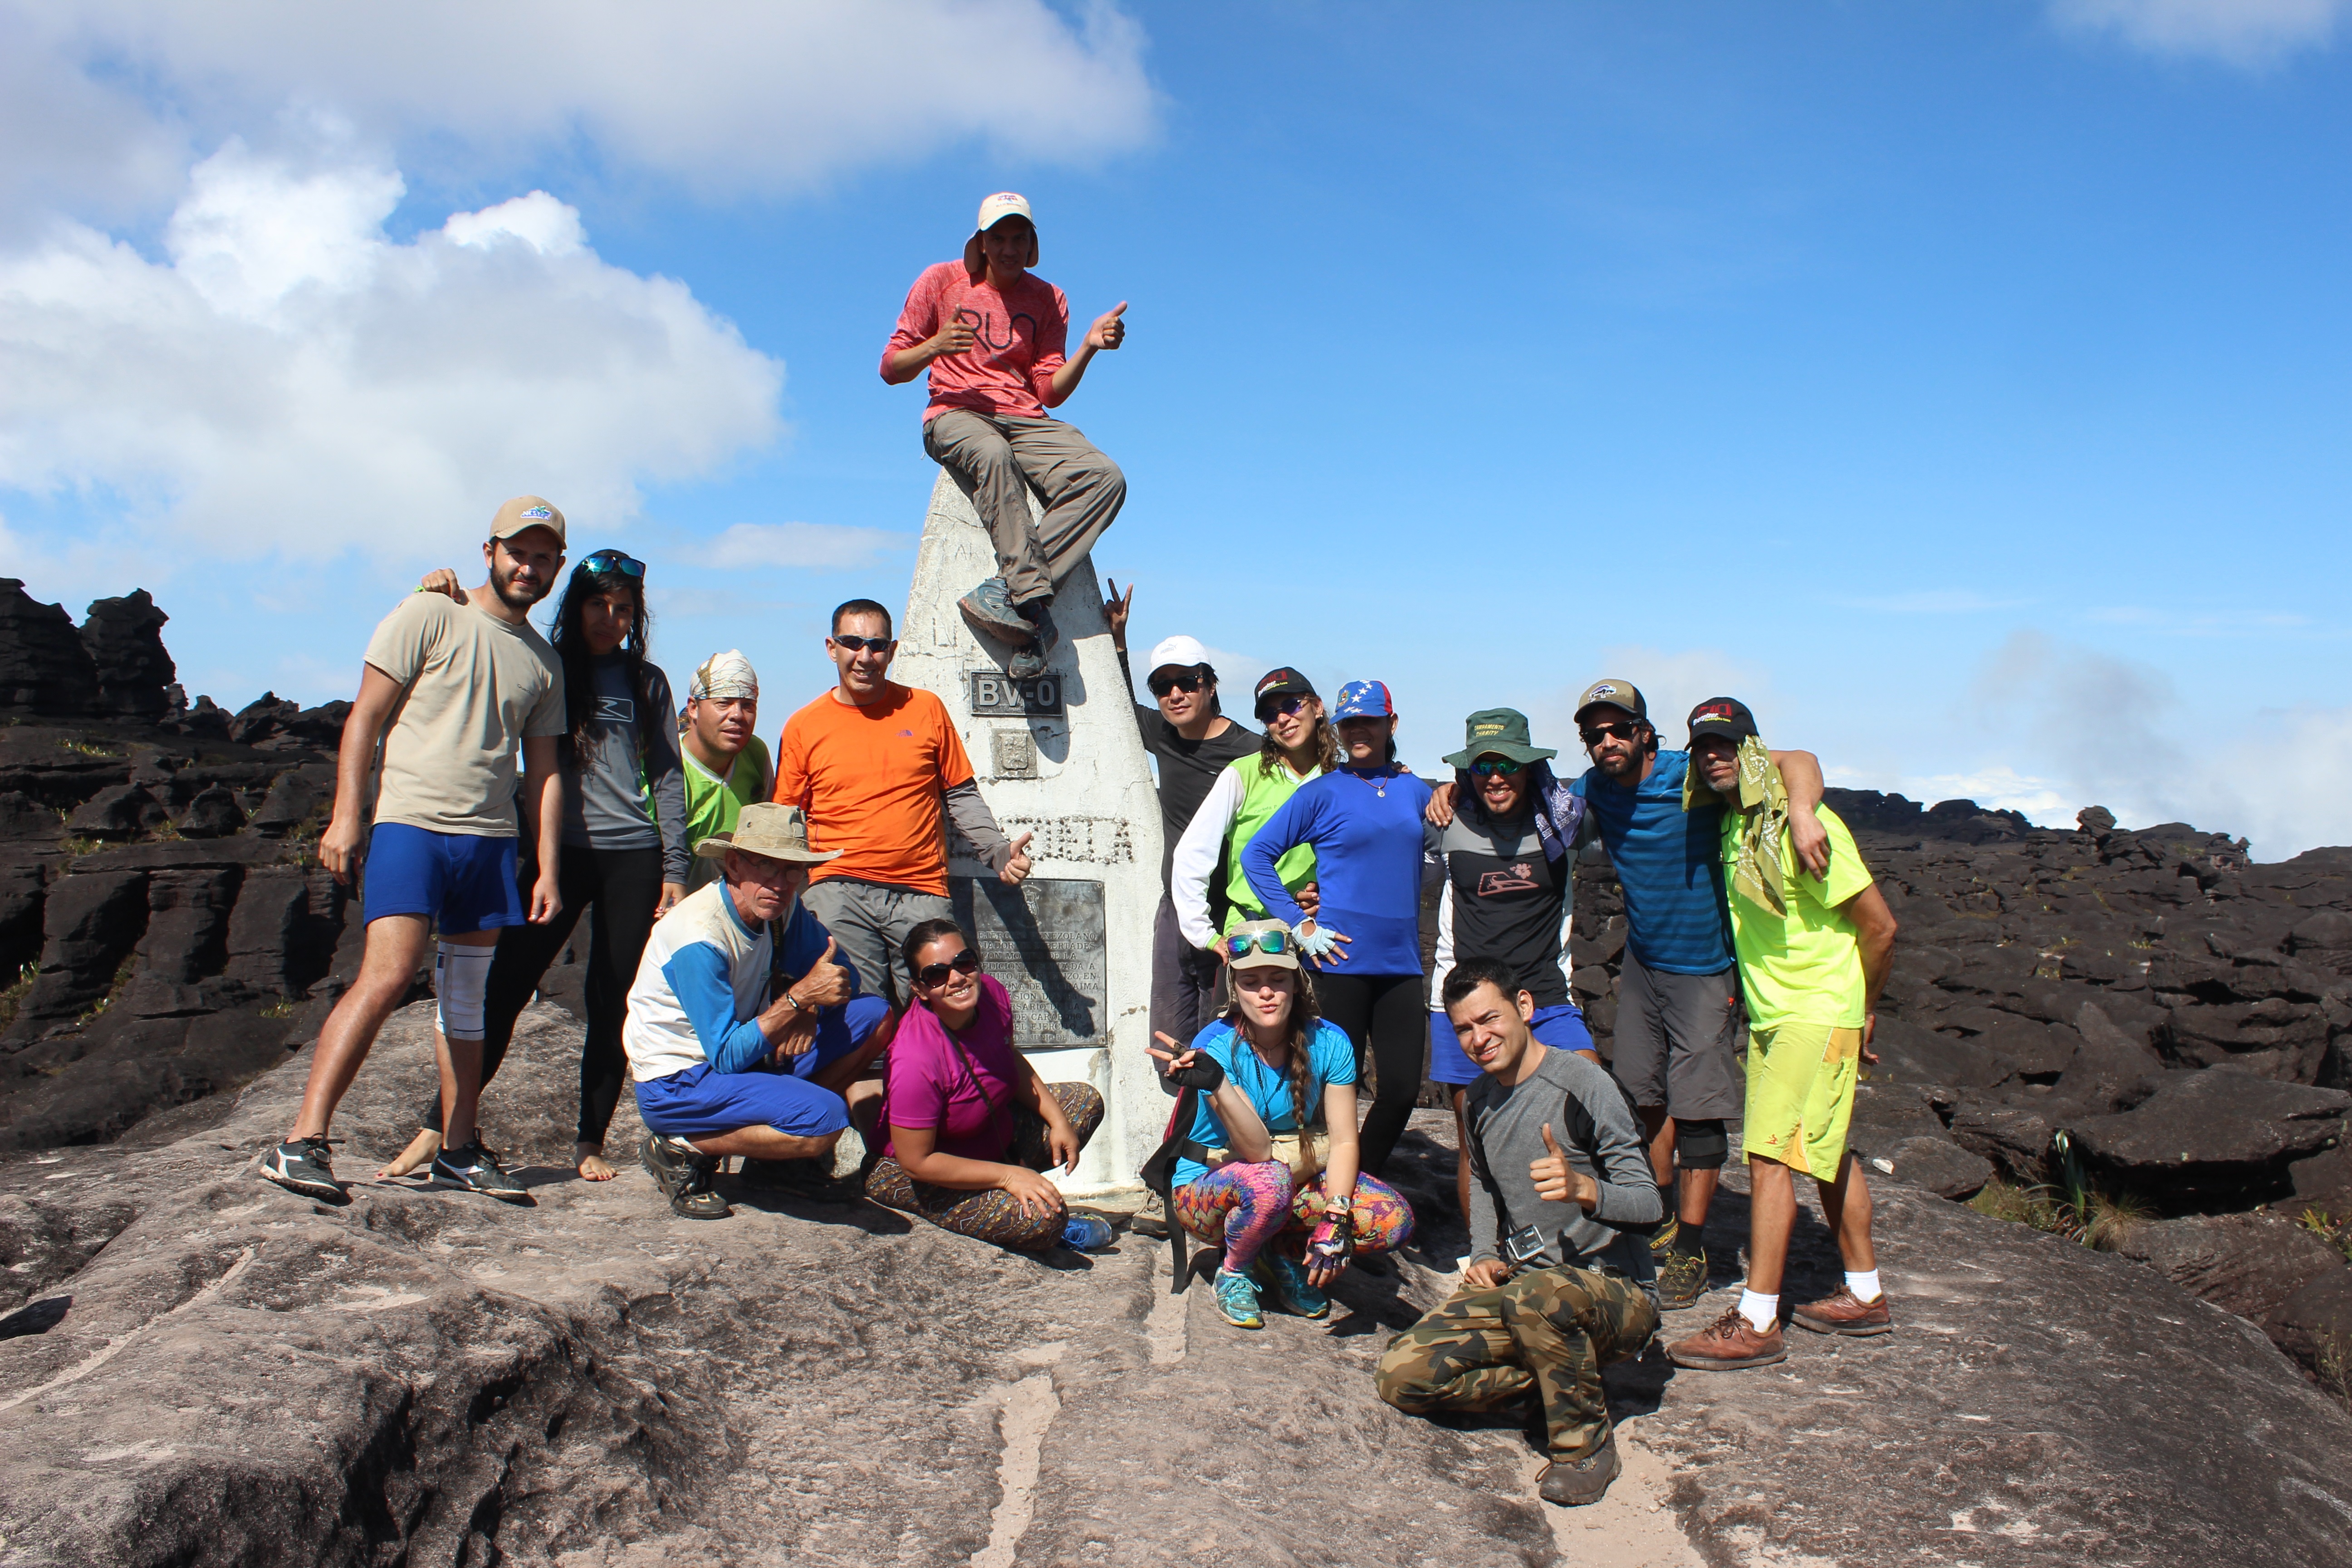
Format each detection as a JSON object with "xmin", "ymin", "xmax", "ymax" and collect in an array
[{"xmin": 866, "ymin": 919, "xmax": 1103, "ymax": 1251}]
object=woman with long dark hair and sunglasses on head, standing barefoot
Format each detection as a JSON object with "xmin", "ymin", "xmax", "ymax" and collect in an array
[{"xmin": 383, "ymin": 550, "xmax": 691, "ymax": 1182}]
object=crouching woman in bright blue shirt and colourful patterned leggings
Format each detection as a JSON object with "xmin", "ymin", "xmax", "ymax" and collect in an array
[{"xmin": 1152, "ymin": 919, "xmax": 1414, "ymax": 1328}]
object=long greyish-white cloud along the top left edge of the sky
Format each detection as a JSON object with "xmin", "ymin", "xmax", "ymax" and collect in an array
[{"xmin": 0, "ymin": 0, "xmax": 1157, "ymax": 206}]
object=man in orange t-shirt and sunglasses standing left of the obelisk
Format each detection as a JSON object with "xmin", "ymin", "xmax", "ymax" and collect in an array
[{"xmin": 776, "ymin": 599, "xmax": 1030, "ymax": 1001}]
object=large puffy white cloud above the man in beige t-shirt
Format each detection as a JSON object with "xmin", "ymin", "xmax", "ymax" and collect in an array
[{"xmin": 0, "ymin": 139, "xmax": 783, "ymax": 576}]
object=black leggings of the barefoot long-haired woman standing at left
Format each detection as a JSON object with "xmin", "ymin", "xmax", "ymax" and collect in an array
[{"xmin": 419, "ymin": 844, "xmax": 661, "ymax": 1147}]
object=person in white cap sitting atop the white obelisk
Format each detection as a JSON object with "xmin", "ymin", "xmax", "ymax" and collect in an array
[{"xmin": 882, "ymin": 191, "xmax": 1127, "ymax": 679}]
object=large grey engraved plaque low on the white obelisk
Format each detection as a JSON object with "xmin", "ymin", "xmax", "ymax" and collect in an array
[{"xmin": 948, "ymin": 877, "xmax": 1108, "ymax": 1051}]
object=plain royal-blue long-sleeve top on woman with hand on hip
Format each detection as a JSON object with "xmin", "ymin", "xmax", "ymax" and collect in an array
[{"xmin": 1242, "ymin": 769, "xmax": 1430, "ymax": 975}]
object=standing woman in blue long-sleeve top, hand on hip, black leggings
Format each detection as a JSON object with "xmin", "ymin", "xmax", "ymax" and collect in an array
[{"xmin": 1242, "ymin": 682, "xmax": 1430, "ymax": 1176}]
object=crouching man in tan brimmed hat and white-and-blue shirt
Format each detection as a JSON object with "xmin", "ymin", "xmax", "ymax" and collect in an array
[{"xmin": 621, "ymin": 802, "xmax": 894, "ymax": 1220}]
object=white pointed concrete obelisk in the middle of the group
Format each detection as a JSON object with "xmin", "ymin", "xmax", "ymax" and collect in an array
[{"xmin": 892, "ymin": 472, "xmax": 1169, "ymax": 1196}]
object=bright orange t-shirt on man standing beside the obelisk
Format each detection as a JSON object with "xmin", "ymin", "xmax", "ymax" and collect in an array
[{"xmin": 776, "ymin": 682, "xmax": 971, "ymax": 893}]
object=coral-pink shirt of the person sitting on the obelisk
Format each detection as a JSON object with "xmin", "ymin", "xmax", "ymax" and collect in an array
[{"xmin": 882, "ymin": 261, "xmax": 1070, "ymax": 423}]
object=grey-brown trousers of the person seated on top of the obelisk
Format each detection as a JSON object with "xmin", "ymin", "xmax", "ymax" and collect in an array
[{"xmin": 922, "ymin": 409, "xmax": 1127, "ymax": 604}]
